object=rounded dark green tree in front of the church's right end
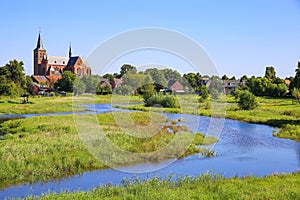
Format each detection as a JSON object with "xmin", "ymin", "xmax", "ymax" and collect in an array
[{"xmin": 54, "ymin": 71, "xmax": 76, "ymax": 92}]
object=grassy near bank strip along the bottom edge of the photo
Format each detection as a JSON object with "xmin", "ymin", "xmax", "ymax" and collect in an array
[{"xmin": 28, "ymin": 173, "xmax": 300, "ymax": 200}]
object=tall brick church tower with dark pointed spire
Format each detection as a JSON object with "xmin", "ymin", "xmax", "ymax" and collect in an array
[{"xmin": 33, "ymin": 33, "xmax": 46, "ymax": 75}]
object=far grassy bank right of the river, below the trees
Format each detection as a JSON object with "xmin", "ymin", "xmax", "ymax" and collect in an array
[{"xmin": 118, "ymin": 95, "xmax": 300, "ymax": 141}]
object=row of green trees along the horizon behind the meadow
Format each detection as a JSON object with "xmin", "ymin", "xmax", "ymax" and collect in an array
[{"xmin": 0, "ymin": 60, "xmax": 300, "ymax": 104}]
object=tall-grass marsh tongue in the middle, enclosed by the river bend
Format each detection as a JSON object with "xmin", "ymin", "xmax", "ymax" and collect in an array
[{"xmin": 0, "ymin": 112, "xmax": 216, "ymax": 188}]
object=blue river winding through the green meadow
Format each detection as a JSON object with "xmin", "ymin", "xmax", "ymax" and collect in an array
[{"xmin": 0, "ymin": 104, "xmax": 300, "ymax": 199}]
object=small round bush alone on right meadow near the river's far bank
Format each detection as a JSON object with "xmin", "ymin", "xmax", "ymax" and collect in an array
[{"xmin": 237, "ymin": 90, "xmax": 257, "ymax": 110}]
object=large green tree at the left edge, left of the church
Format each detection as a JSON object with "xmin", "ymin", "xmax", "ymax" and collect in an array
[{"xmin": 0, "ymin": 60, "xmax": 26, "ymax": 96}]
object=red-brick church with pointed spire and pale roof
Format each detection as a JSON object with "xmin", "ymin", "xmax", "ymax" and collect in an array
[{"xmin": 32, "ymin": 33, "xmax": 91, "ymax": 86}]
